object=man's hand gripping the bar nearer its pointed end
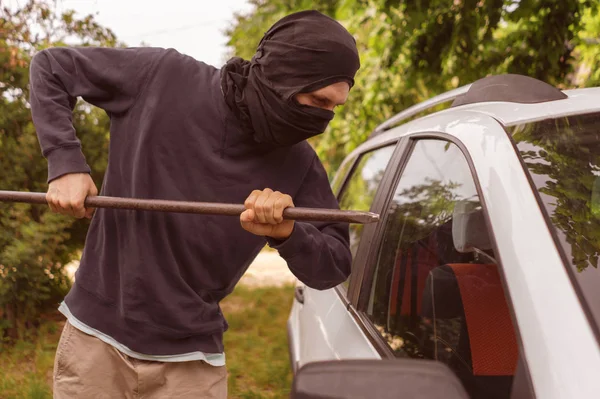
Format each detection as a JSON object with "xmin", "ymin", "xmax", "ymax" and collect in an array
[{"xmin": 240, "ymin": 188, "xmax": 294, "ymax": 240}]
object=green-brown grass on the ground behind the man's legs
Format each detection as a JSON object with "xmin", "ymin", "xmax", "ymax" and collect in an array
[{"xmin": 0, "ymin": 286, "xmax": 293, "ymax": 399}]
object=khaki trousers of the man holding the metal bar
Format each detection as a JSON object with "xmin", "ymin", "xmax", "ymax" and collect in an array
[{"xmin": 54, "ymin": 321, "xmax": 227, "ymax": 399}]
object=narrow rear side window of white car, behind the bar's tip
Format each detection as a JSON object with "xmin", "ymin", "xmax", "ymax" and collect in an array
[{"xmin": 338, "ymin": 144, "xmax": 395, "ymax": 287}]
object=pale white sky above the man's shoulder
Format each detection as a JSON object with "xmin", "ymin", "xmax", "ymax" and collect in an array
[{"xmin": 8, "ymin": 0, "xmax": 252, "ymax": 67}]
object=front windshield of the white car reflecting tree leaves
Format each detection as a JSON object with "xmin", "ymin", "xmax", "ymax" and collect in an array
[{"xmin": 509, "ymin": 113, "xmax": 600, "ymax": 338}]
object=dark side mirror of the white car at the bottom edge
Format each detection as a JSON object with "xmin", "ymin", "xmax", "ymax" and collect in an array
[{"xmin": 291, "ymin": 359, "xmax": 469, "ymax": 399}]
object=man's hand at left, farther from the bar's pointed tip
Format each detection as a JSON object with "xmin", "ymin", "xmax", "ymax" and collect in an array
[{"xmin": 46, "ymin": 173, "xmax": 98, "ymax": 219}]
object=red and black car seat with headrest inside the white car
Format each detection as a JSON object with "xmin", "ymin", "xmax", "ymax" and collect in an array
[{"xmin": 422, "ymin": 201, "xmax": 518, "ymax": 399}]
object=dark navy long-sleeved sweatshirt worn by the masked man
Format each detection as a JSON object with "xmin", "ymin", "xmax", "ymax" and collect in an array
[{"xmin": 30, "ymin": 48, "xmax": 351, "ymax": 355}]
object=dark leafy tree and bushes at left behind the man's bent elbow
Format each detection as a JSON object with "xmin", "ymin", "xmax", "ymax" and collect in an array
[{"xmin": 0, "ymin": 0, "xmax": 118, "ymax": 340}]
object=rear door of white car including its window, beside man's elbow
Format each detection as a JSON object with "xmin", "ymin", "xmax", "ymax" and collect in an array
[{"xmin": 288, "ymin": 142, "xmax": 398, "ymax": 369}]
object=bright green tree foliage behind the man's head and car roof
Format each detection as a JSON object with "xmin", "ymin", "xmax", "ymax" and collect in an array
[{"xmin": 227, "ymin": 0, "xmax": 600, "ymax": 174}]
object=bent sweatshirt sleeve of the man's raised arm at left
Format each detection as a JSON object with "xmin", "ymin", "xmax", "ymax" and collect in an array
[{"xmin": 29, "ymin": 47, "xmax": 165, "ymax": 182}]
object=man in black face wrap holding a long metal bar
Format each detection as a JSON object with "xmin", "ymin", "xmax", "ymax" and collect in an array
[{"xmin": 31, "ymin": 11, "xmax": 359, "ymax": 398}]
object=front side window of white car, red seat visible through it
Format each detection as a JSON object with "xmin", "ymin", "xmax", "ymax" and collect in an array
[{"xmin": 363, "ymin": 139, "xmax": 519, "ymax": 399}]
